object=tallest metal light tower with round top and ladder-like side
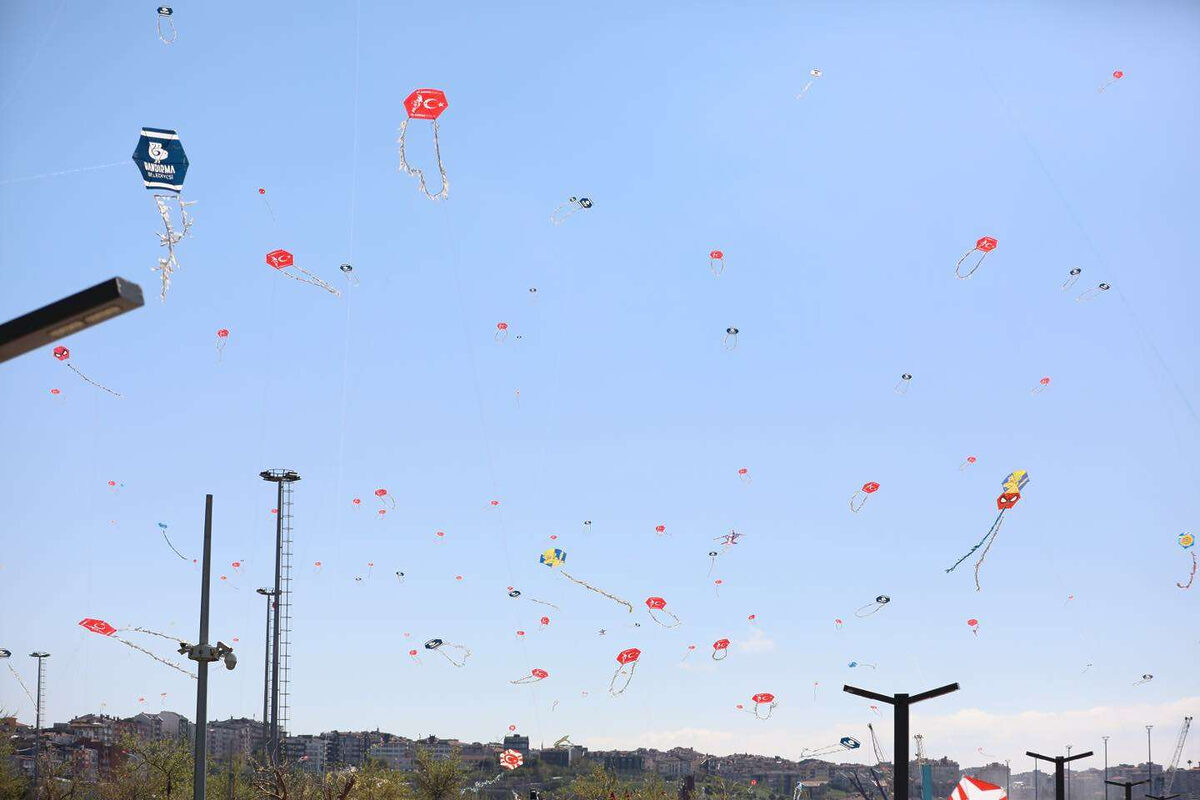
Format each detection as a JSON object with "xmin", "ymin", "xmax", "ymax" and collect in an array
[{"xmin": 258, "ymin": 469, "xmax": 300, "ymax": 764}]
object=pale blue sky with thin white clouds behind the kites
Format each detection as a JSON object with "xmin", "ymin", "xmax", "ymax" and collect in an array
[{"xmin": 0, "ymin": 0, "xmax": 1200, "ymax": 763}]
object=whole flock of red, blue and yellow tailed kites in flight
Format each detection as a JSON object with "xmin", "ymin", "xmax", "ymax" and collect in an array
[{"xmin": 9, "ymin": 6, "xmax": 1180, "ymax": 767}]
